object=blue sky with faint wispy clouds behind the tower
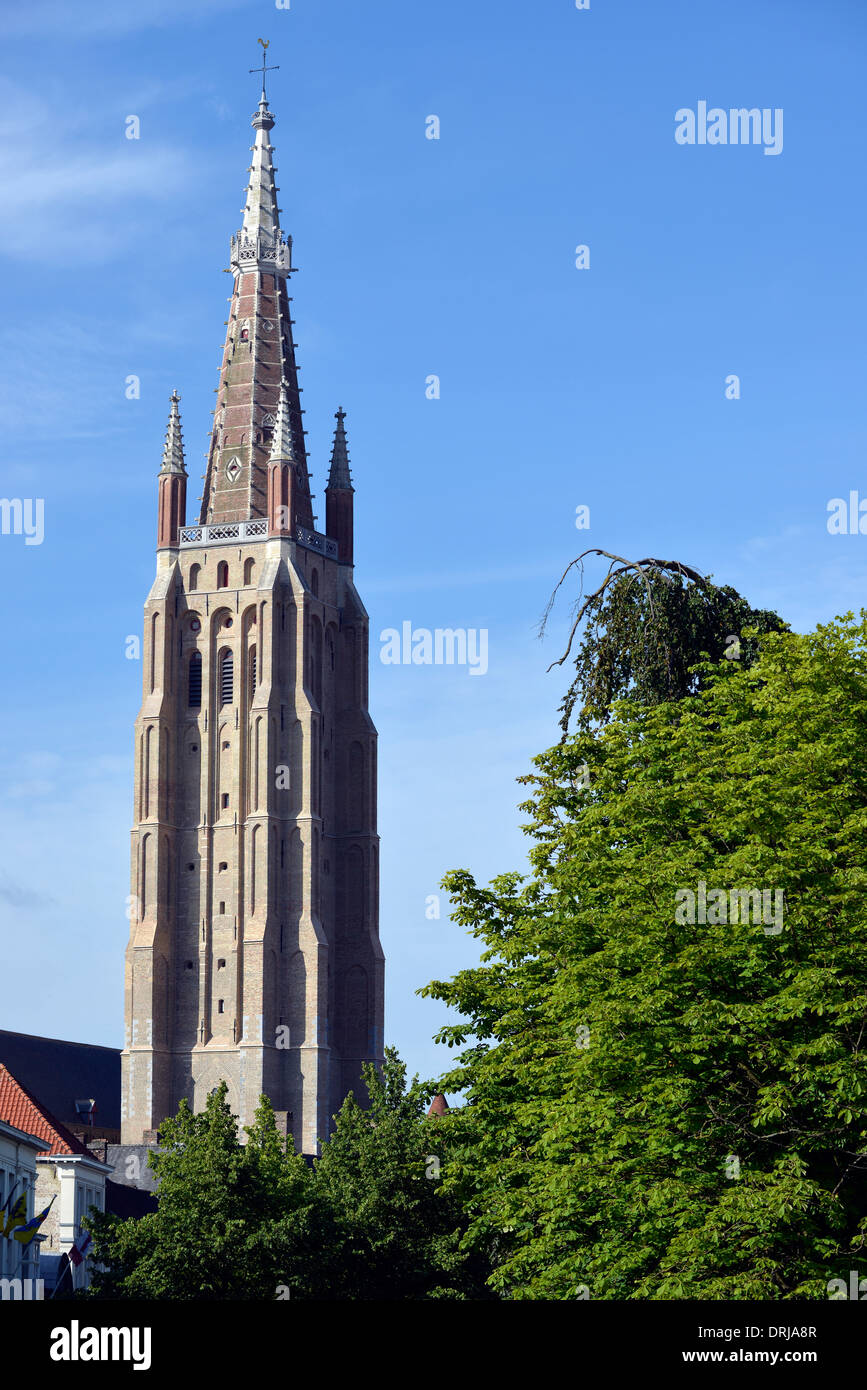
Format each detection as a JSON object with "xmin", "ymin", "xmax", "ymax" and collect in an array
[{"xmin": 0, "ymin": 0, "xmax": 867, "ymax": 1074}]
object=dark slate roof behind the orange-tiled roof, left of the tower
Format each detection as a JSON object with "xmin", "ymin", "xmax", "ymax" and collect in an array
[{"xmin": 0, "ymin": 1029, "xmax": 121, "ymax": 1130}]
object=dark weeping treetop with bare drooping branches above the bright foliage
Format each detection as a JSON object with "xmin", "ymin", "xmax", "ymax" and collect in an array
[{"xmin": 540, "ymin": 549, "xmax": 786, "ymax": 733}]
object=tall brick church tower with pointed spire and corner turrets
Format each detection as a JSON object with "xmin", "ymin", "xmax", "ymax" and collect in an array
[{"xmin": 121, "ymin": 70, "xmax": 383, "ymax": 1154}]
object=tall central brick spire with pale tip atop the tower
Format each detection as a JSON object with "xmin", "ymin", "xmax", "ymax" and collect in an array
[{"xmin": 200, "ymin": 90, "xmax": 313, "ymax": 530}]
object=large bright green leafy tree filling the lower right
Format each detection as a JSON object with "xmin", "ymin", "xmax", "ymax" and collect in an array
[{"xmin": 422, "ymin": 614, "xmax": 867, "ymax": 1300}]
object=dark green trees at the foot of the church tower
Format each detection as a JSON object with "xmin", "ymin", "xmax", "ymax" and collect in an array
[{"xmin": 89, "ymin": 1049, "xmax": 492, "ymax": 1300}]
